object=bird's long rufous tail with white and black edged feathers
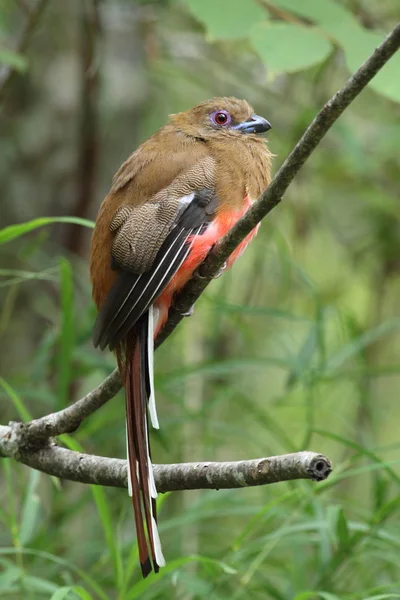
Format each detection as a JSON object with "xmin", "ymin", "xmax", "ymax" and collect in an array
[{"xmin": 125, "ymin": 307, "xmax": 165, "ymax": 577}]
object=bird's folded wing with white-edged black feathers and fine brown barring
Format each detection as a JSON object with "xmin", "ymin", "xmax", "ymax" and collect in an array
[{"xmin": 93, "ymin": 188, "xmax": 218, "ymax": 350}]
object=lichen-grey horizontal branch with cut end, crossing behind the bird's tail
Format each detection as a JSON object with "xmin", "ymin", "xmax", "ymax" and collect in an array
[{"xmin": 0, "ymin": 423, "xmax": 332, "ymax": 492}]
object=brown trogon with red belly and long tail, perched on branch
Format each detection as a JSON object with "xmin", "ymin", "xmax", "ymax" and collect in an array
[{"xmin": 90, "ymin": 97, "xmax": 272, "ymax": 577}]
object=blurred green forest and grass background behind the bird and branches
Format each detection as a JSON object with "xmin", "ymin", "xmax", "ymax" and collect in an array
[{"xmin": 0, "ymin": 0, "xmax": 400, "ymax": 600}]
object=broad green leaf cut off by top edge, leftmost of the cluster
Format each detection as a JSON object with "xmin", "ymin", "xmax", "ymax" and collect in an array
[{"xmin": 186, "ymin": 0, "xmax": 267, "ymax": 40}]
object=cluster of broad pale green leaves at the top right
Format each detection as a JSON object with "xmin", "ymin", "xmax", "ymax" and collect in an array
[{"xmin": 185, "ymin": 0, "xmax": 400, "ymax": 102}]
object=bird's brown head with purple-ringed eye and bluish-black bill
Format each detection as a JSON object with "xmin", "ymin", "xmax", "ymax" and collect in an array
[{"xmin": 171, "ymin": 98, "xmax": 271, "ymax": 139}]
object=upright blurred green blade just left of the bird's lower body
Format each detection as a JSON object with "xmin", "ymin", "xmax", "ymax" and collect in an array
[{"xmin": 57, "ymin": 258, "xmax": 75, "ymax": 407}]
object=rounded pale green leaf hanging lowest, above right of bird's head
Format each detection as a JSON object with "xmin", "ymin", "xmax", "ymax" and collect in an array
[{"xmin": 250, "ymin": 22, "xmax": 332, "ymax": 73}]
